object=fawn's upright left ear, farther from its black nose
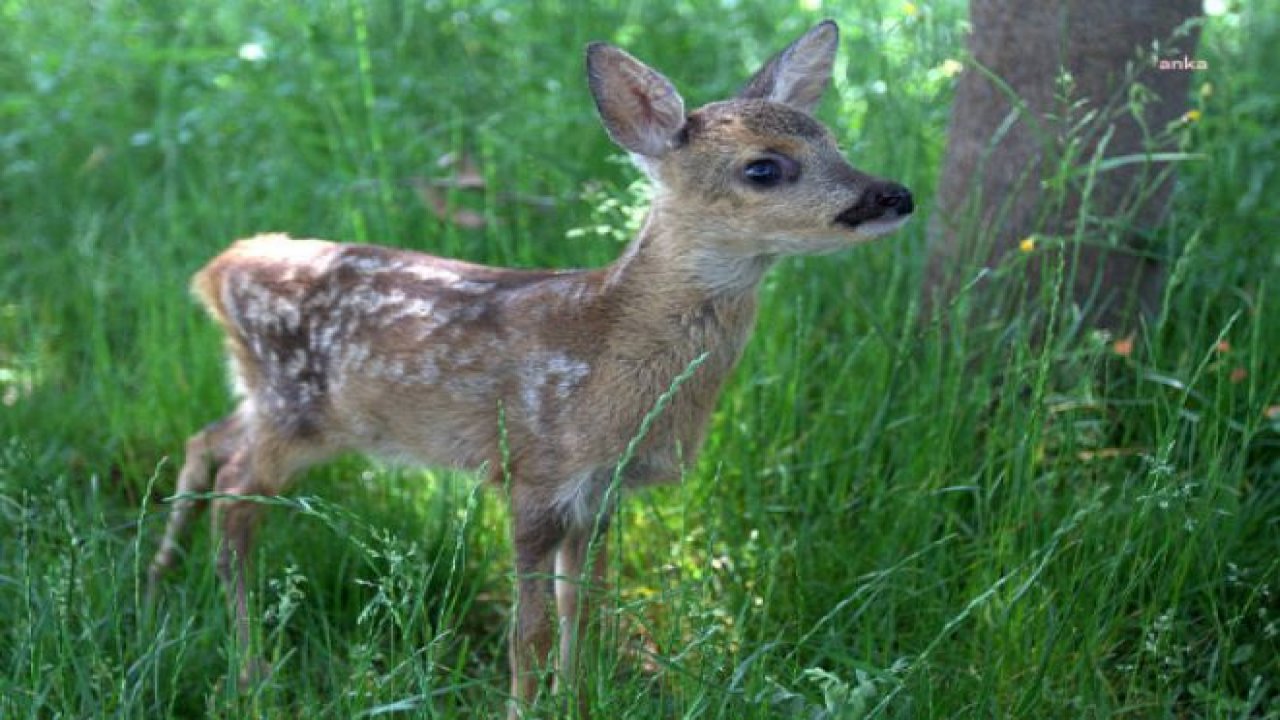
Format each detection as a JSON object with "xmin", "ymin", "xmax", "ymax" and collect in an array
[{"xmin": 586, "ymin": 42, "xmax": 685, "ymax": 159}]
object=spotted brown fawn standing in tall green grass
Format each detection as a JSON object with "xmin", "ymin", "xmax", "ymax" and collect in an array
[{"xmin": 151, "ymin": 20, "xmax": 913, "ymax": 717}]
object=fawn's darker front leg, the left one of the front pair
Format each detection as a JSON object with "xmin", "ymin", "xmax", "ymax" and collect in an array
[{"xmin": 507, "ymin": 493, "xmax": 564, "ymax": 720}]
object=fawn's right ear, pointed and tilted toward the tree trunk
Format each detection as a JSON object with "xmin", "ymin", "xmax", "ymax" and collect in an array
[{"xmin": 737, "ymin": 20, "xmax": 840, "ymax": 113}]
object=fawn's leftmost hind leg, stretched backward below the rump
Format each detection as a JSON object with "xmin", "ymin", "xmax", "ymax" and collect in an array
[{"xmin": 147, "ymin": 413, "xmax": 243, "ymax": 598}]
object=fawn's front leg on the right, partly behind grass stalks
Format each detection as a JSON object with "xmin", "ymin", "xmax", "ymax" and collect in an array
[{"xmin": 556, "ymin": 523, "xmax": 607, "ymax": 717}]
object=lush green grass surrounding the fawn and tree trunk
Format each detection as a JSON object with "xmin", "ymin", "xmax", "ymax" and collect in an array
[{"xmin": 0, "ymin": 0, "xmax": 1280, "ymax": 720}]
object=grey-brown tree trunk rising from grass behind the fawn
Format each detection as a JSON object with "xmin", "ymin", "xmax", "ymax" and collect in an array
[{"xmin": 924, "ymin": 0, "xmax": 1199, "ymax": 328}]
